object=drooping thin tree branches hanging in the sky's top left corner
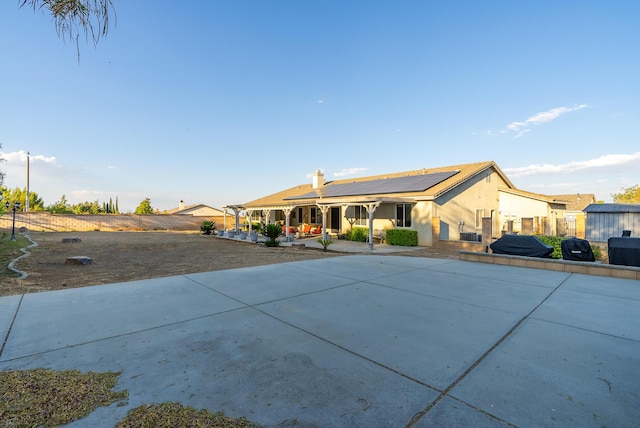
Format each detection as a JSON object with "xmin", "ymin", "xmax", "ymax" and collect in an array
[{"xmin": 19, "ymin": 0, "xmax": 115, "ymax": 55}]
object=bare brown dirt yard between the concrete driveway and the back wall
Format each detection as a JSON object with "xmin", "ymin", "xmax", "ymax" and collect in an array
[{"xmin": 0, "ymin": 232, "xmax": 458, "ymax": 296}]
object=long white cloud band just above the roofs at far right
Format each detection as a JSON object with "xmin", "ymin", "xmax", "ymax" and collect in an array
[{"xmin": 504, "ymin": 152, "xmax": 640, "ymax": 177}]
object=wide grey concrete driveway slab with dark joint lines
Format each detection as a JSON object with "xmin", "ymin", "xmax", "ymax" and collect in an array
[{"xmin": 0, "ymin": 255, "xmax": 640, "ymax": 427}]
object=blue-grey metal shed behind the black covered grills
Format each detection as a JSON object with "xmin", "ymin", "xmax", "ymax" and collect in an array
[{"xmin": 584, "ymin": 204, "xmax": 640, "ymax": 242}]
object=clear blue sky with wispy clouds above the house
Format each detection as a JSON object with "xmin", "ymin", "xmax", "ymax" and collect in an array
[{"xmin": 0, "ymin": 0, "xmax": 640, "ymax": 212}]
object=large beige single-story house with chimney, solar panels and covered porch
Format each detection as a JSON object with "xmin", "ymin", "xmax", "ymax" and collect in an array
[{"xmin": 238, "ymin": 161, "xmax": 566, "ymax": 246}]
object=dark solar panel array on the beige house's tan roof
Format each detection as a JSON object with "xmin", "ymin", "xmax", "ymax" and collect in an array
[{"xmin": 285, "ymin": 171, "xmax": 459, "ymax": 199}]
